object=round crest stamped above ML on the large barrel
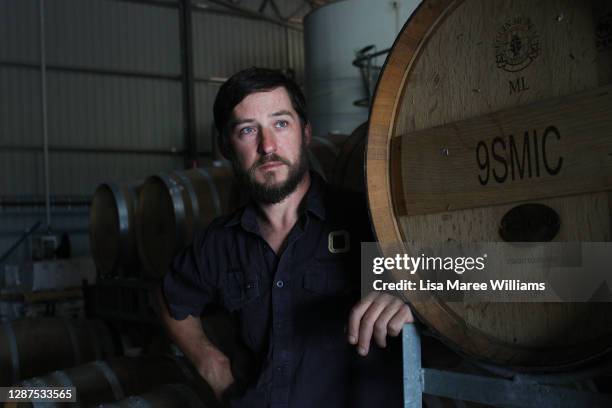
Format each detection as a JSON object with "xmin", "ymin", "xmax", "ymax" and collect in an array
[{"xmin": 495, "ymin": 17, "xmax": 540, "ymax": 72}]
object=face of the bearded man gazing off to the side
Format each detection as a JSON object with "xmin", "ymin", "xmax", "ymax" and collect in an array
[{"xmin": 230, "ymin": 87, "xmax": 310, "ymax": 204}]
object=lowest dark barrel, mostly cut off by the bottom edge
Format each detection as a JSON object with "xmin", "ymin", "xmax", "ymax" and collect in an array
[{"xmin": 99, "ymin": 383, "xmax": 208, "ymax": 408}]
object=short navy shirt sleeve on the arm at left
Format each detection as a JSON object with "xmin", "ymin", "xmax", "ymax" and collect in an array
[{"xmin": 162, "ymin": 225, "xmax": 217, "ymax": 320}]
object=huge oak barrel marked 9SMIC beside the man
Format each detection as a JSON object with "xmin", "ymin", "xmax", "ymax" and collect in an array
[{"xmin": 366, "ymin": 0, "xmax": 612, "ymax": 370}]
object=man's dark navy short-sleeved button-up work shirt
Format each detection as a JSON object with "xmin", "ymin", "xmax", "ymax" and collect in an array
[{"xmin": 163, "ymin": 172, "xmax": 402, "ymax": 408}]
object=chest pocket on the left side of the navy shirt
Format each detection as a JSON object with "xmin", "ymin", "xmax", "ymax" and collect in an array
[{"xmin": 222, "ymin": 268, "xmax": 260, "ymax": 312}]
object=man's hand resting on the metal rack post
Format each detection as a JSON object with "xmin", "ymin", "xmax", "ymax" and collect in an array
[{"xmin": 348, "ymin": 292, "xmax": 414, "ymax": 356}]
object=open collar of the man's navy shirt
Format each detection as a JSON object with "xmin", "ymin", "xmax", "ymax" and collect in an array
[{"xmin": 224, "ymin": 171, "xmax": 325, "ymax": 234}]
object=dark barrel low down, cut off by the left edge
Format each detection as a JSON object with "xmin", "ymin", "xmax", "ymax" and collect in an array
[{"xmin": 0, "ymin": 318, "xmax": 117, "ymax": 386}]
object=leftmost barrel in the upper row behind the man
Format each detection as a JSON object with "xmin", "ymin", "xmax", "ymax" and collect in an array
[{"xmin": 89, "ymin": 181, "xmax": 142, "ymax": 277}]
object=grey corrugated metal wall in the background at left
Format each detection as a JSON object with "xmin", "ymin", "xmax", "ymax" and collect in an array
[{"xmin": 0, "ymin": 0, "xmax": 309, "ymax": 268}]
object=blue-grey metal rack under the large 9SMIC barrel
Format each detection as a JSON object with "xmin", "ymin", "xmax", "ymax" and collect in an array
[{"xmin": 402, "ymin": 324, "xmax": 612, "ymax": 408}]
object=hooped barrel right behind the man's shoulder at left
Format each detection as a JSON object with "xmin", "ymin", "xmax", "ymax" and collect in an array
[{"xmin": 137, "ymin": 164, "xmax": 240, "ymax": 279}]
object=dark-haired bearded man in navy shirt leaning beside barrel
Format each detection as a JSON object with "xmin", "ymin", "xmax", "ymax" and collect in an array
[{"xmin": 161, "ymin": 68, "xmax": 413, "ymax": 408}]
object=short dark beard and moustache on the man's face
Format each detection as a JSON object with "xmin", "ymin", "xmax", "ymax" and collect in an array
[{"xmin": 232, "ymin": 137, "xmax": 309, "ymax": 204}]
